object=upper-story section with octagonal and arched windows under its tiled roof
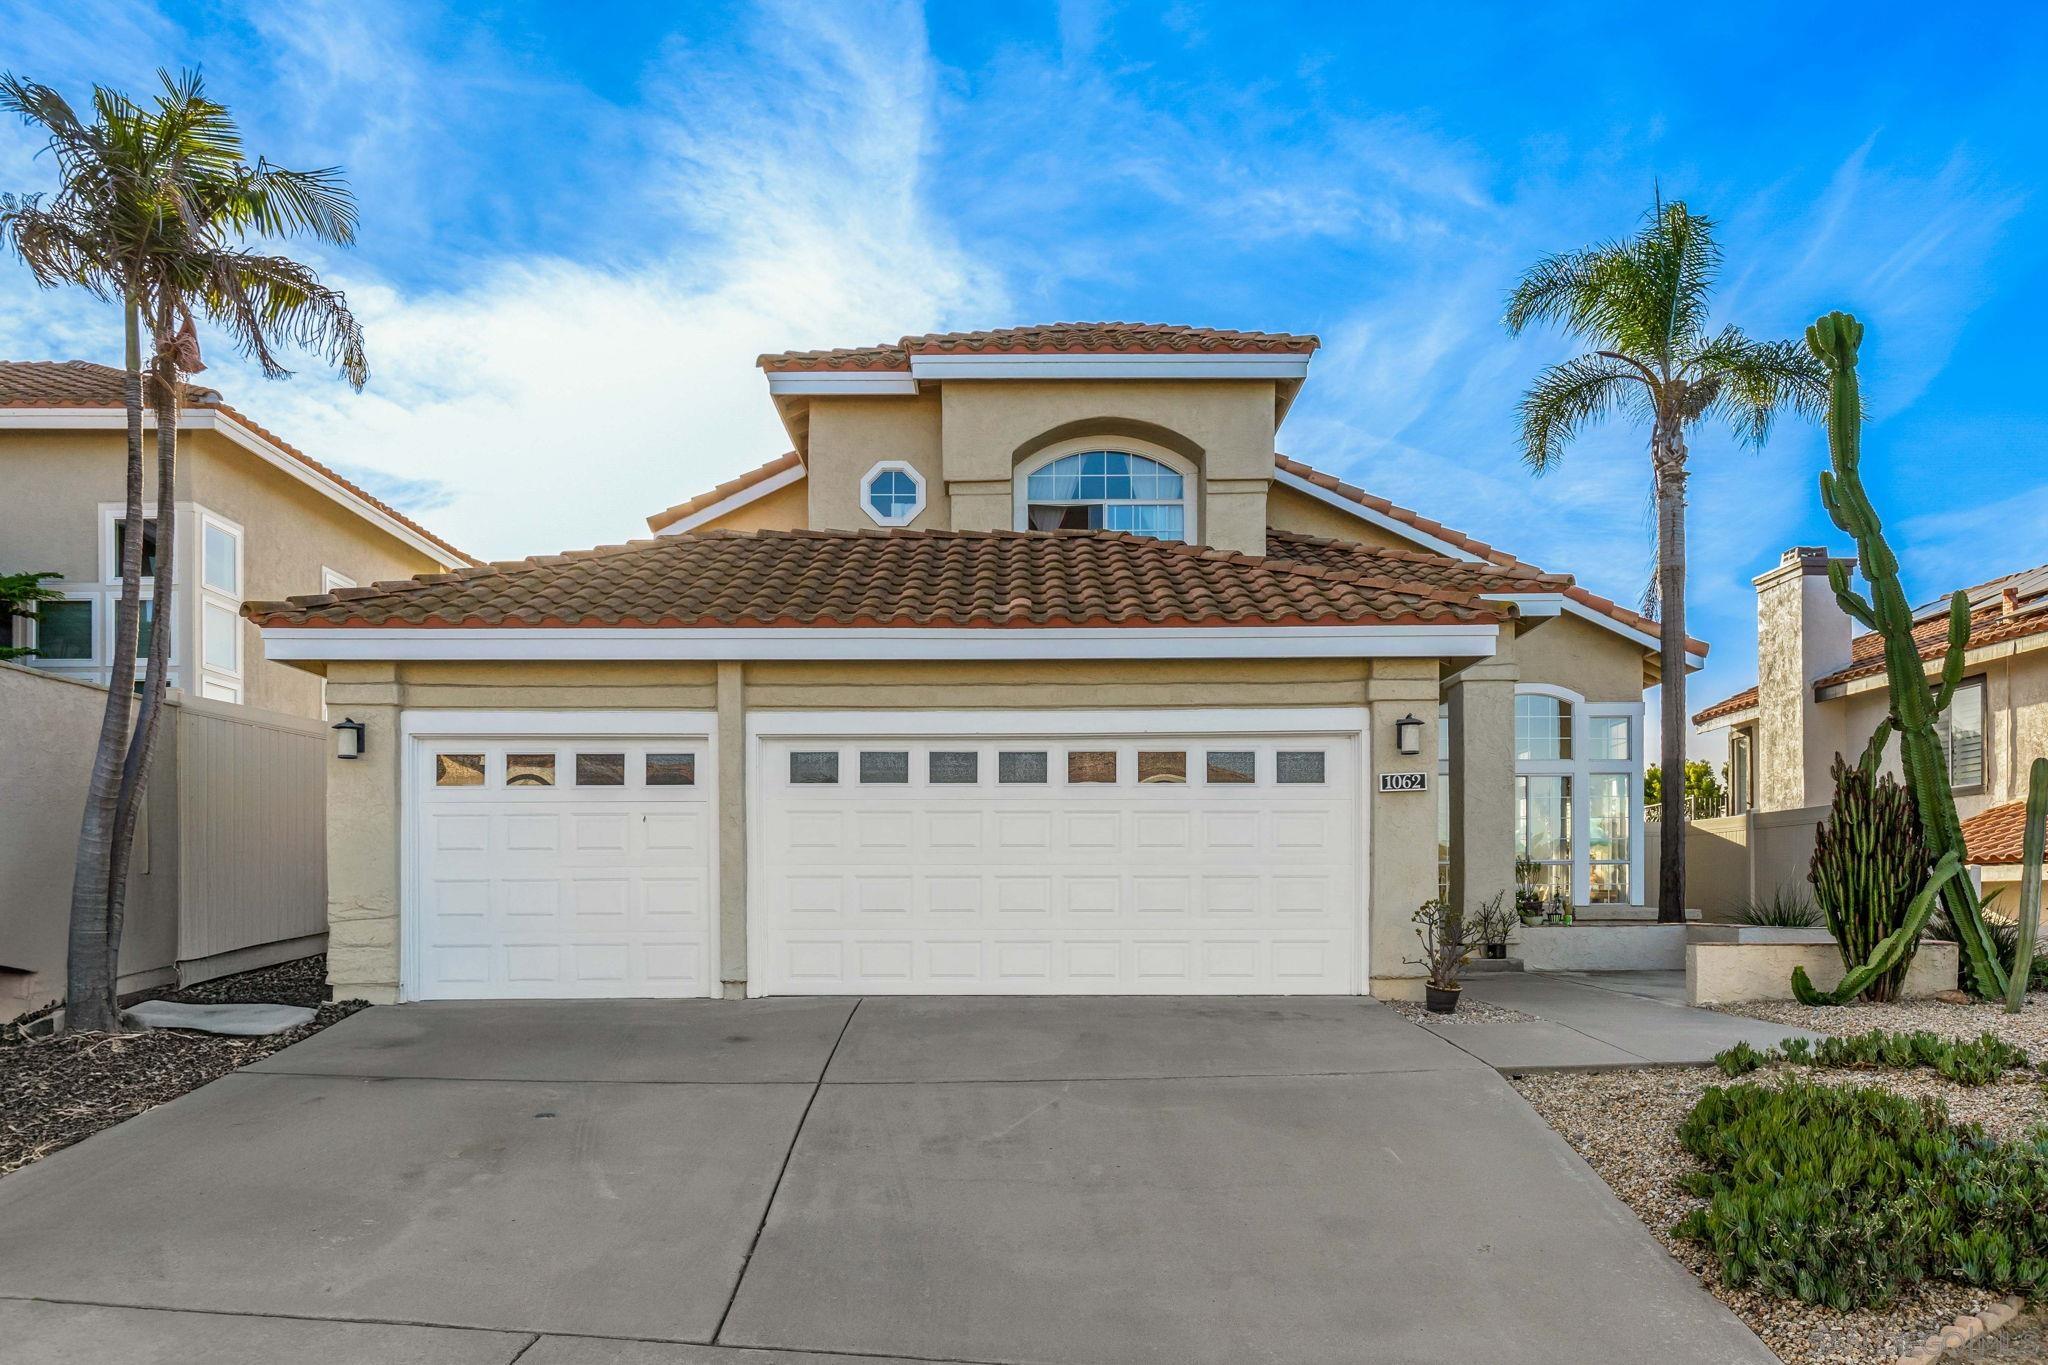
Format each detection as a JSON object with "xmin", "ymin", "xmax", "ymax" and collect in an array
[{"xmin": 760, "ymin": 323, "xmax": 1317, "ymax": 555}]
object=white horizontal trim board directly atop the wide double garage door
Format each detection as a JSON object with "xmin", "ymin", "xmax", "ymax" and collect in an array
[{"xmin": 748, "ymin": 706, "xmax": 1368, "ymax": 739}]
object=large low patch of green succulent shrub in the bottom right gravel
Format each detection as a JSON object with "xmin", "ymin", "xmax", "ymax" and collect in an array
[{"xmin": 1673, "ymin": 1080, "xmax": 2048, "ymax": 1312}]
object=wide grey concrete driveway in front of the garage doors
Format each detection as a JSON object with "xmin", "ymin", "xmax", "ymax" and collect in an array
[{"xmin": 0, "ymin": 999, "xmax": 1774, "ymax": 1365}]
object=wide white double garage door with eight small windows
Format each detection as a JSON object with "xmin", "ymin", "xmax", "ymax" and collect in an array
[{"xmin": 750, "ymin": 712, "xmax": 1364, "ymax": 995}]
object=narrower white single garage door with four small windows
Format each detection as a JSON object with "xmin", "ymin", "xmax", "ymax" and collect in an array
[{"xmin": 401, "ymin": 735, "xmax": 719, "ymax": 1001}]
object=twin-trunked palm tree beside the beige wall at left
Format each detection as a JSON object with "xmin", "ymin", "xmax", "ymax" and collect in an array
[{"xmin": 0, "ymin": 72, "xmax": 369, "ymax": 1029}]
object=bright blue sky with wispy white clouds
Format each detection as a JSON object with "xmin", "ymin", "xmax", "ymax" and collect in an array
[{"xmin": 0, "ymin": 0, "xmax": 2048, "ymax": 757}]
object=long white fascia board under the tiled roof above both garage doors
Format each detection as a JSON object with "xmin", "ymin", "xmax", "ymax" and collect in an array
[{"xmin": 262, "ymin": 624, "xmax": 1497, "ymax": 661}]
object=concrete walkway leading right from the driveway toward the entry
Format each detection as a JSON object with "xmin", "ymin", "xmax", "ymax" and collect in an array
[{"xmin": 1423, "ymin": 972, "xmax": 1819, "ymax": 1074}]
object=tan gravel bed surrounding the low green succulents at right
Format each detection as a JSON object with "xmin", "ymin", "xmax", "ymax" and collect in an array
[{"xmin": 1513, "ymin": 1064, "xmax": 2023, "ymax": 1365}]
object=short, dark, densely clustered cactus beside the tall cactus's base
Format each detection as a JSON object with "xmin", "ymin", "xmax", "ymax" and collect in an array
[{"xmin": 1810, "ymin": 753, "xmax": 1927, "ymax": 1001}]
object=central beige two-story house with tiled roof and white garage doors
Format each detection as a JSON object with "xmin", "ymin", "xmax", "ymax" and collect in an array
[{"xmin": 246, "ymin": 323, "xmax": 1706, "ymax": 1001}]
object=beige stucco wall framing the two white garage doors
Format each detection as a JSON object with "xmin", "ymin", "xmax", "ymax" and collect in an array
[{"xmin": 328, "ymin": 659, "xmax": 1438, "ymax": 1001}]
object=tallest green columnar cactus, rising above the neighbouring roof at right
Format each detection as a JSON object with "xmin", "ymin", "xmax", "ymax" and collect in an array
[{"xmin": 1792, "ymin": 313, "xmax": 2005, "ymax": 1001}]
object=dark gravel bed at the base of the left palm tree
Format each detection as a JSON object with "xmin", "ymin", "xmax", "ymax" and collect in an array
[{"xmin": 0, "ymin": 956, "xmax": 369, "ymax": 1175}]
